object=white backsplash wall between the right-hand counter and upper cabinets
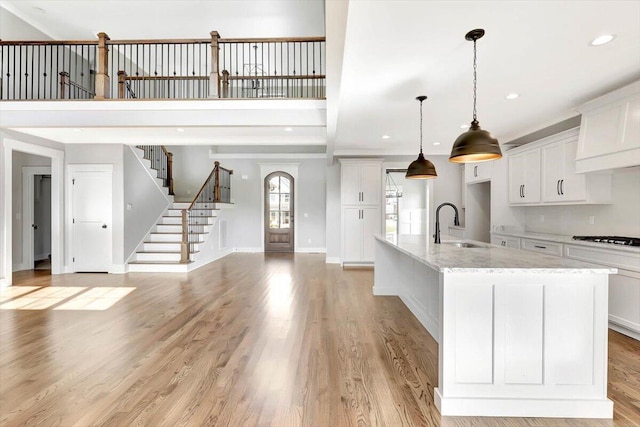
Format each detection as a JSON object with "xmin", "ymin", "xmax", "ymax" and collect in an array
[{"xmin": 520, "ymin": 166, "xmax": 640, "ymax": 237}]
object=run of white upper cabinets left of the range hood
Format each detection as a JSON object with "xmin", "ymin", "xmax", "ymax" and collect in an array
[{"xmin": 508, "ymin": 128, "xmax": 611, "ymax": 205}]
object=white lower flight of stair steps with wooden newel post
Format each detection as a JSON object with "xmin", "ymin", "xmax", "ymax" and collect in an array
[{"xmin": 129, "ymin": 202, "xmax": 218, "ymax": 272}]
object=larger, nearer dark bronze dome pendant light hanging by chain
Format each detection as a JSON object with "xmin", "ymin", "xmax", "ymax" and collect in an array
[{"xmin": 449, "ymin": 29, "xmax": 502, "ymax": 163}]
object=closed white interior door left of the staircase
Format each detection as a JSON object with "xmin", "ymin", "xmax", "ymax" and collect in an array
[{"xmin": 71, "ymin": 171, "xmax": 113, "ymax": 272}]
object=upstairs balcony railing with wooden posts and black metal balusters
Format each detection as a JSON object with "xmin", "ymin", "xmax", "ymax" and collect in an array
[{"xmin": 0, "ymin": 31, "xmax": 326, "ymax": 100}]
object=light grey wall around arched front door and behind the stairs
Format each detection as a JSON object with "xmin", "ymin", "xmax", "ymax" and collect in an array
[{"xmin": 167, "ymin": 146, "xmax": 326, "ymax": 251}]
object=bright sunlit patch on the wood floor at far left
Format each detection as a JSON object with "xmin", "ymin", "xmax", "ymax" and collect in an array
[{"xmin": 0, "ymin": 286, "xmax": 136, "ymax": 311}]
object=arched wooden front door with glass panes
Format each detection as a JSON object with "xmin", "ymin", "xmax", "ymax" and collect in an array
[{"xmin": 264, "ymin": 172, "xmax": 294, "ymax": 252}]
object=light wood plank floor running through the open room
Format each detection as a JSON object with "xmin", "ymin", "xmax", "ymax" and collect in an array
[{"xmin": 0, "ymin": 254, "xmax": 640, "ymax": 427}]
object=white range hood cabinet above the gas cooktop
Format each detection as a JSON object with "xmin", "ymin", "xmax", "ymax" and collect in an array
[{"xmin": 576, "ymin": 81, "xmax": 640, "ymax": 172}]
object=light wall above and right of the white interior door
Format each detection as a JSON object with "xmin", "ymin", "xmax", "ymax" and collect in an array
[{"xmin": 65, "ymin": 144, "xmax": 125, "ymax": 272}]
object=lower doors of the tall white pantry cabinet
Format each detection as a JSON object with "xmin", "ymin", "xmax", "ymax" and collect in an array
[{"xmin": 342, "ymin": 206, "xmax": 380, "ymax": 264}]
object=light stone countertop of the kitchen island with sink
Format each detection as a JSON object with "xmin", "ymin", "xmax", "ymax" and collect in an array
[{"xmin": 375, "ymin": 235, "xmax": 617, "ymax": 274}]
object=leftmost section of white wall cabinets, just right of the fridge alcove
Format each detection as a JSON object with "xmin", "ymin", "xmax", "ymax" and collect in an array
[{"xmin": 509, "ymin": 148, "xmax": 540, "ymax": 205}]
